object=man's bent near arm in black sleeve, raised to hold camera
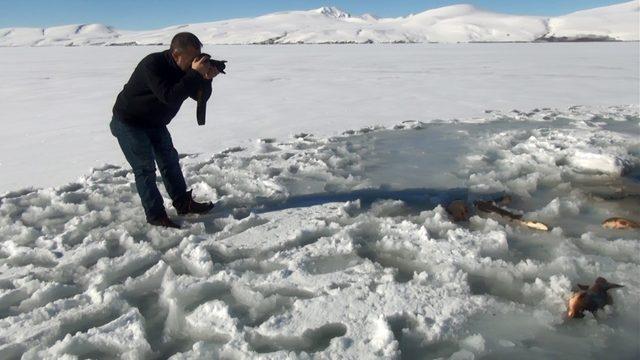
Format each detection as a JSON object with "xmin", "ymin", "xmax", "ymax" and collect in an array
[{"xmin": 144, "ymin": 59, "xmax": 204, "ymax": 105}]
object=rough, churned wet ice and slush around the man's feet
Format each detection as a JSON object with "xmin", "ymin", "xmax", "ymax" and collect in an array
[{"xmin": 0, "ymin": 106, "xmax": 640, "ymax": 359}]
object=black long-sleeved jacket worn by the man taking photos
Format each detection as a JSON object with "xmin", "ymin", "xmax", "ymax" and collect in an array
[{"xmin": 113, "ymin": 50, "xmax": 211, "ymax": 127}]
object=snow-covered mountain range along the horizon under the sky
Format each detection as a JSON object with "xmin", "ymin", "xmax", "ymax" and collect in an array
[{"xmin": 0, "ymin": 0, "xmax": 640, "ymax": 46}]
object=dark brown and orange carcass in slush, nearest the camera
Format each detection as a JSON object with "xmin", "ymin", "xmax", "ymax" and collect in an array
[{"xmin": 567, "ymin": 277, "xmax": 624, "ymax": 319}]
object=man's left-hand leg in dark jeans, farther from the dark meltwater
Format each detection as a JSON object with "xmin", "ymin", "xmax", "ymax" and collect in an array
[{"xmin": 110, "ymin": 119, "xmax": 166, "ymax": 221}]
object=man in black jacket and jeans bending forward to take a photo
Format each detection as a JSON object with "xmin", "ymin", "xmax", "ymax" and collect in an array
[{"xmin": 110, "ymin": 32, "xmax": 218, "ymax": 228}]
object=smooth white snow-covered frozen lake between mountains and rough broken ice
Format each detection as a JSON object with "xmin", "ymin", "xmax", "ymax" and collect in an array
[{"xmin": 0, "ymin": 43, "xmax": 640, "ymax": 193}]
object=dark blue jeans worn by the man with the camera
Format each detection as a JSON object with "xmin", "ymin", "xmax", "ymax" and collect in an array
[{"xmin": 109, "ymin": 117, "xmax": 187, "ymax": 220}]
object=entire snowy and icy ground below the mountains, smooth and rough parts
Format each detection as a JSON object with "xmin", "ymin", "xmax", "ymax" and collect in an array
[{"xmin": 0, "ymin": 43, "xmax": 640, "ymax": 359}]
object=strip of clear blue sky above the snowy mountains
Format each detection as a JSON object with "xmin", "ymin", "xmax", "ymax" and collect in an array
[{"xmin": 0, "ymin": 0, "xmax": 624, "ymax": 30}]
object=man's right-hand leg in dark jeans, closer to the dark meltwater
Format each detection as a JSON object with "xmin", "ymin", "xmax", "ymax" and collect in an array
[{"xmin": 150, "ymin": 126, "xmax": 187, "ymax": 202}]
